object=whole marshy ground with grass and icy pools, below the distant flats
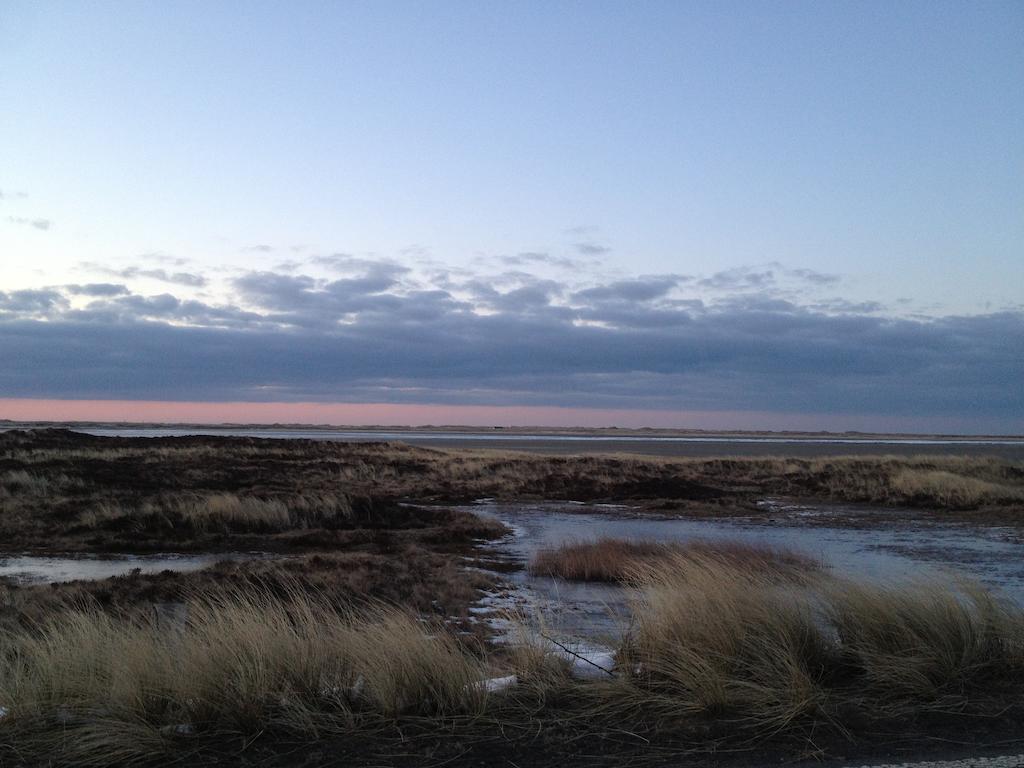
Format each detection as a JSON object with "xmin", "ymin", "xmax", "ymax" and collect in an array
[{"xmin": 0, "ymin": 429, "xmax": 1024, "ymax": 766}]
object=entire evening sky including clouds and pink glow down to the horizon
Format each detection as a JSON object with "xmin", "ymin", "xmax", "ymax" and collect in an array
[{"xmin": 0, "ymin": 0, "xmax": 1024, "ymax": 433}]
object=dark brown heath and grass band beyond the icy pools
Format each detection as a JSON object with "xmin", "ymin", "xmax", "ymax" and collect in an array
[{"xmin": 0, "ymin": 430, "xmax": 1024, "ymax": 550}]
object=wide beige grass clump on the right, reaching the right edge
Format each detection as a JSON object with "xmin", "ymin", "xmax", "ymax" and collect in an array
[{"xmin": 620, "ymin": 555, "xmax": 1024, "ymax": 733}]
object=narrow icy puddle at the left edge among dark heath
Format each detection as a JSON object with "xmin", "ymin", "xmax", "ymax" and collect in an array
[{"xmin": 0, "ymin": 552, "xmax": 268, "ymax": 584}]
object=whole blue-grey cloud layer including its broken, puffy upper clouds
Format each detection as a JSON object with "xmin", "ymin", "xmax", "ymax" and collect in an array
[{"xmin": 0, "ymin": 254, "xmax": 1024, "ymax": 429}]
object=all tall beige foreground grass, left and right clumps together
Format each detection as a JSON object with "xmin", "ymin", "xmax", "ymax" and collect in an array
[{"xmin": 0, "ymin": 552, "xmax": 1024, "ymax": 766}]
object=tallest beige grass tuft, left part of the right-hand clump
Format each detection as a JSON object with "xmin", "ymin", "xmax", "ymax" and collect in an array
[{"xmin": 621, "ymin": 555, "xmax": 831, "ymax": 729}]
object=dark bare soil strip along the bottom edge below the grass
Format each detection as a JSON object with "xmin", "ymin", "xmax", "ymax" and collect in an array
[{"xmin": 41, "ymin": 701, "xmax": 1024, "ymax": 768}]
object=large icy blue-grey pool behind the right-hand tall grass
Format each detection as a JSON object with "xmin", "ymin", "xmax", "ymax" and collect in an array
[{"xmin": 464, "ymin": 500, "xmax": 1024, "ymax": 640}]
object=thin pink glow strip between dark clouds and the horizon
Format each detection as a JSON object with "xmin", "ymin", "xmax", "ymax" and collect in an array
[{"xmin": 0, "ymin": 398, "xmax": 999, "ymax": 433}]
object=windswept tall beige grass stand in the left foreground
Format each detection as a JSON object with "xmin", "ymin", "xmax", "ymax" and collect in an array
[{"xmin": 0, "ymin": 592, "xmax": 485, "ymax": 765}]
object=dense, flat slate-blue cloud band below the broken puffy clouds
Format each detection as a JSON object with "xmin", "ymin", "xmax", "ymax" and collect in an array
[{"xmin": 0, "ymin": 301, "xmax": 1024, "ymax": 423}]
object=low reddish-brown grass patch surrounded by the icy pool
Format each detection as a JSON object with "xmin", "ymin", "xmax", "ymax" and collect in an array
[{"xmin": 529, "ymin": 538, "xmax": 821, "ymax": 583}]
